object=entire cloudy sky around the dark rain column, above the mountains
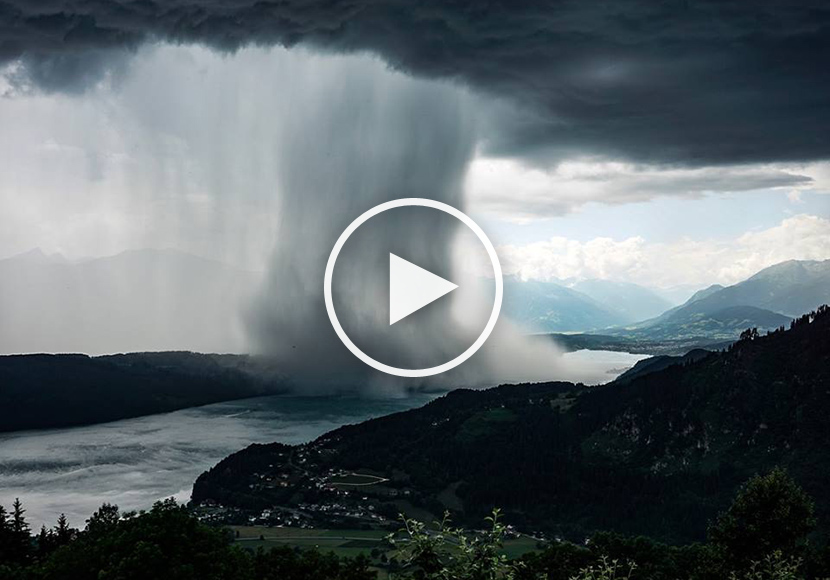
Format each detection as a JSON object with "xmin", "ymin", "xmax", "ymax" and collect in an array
[{"xmin": 0, "ymin": 0, "xmax": 830, "ymax": 287}]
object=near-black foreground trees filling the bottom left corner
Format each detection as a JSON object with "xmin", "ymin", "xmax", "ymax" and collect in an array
[{"xmin": 0, "ymin": 499, "xmax": 374, "ymax": 580}]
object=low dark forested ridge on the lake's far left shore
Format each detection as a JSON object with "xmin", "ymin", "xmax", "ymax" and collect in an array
[{"xmin": 0, "ymin": 352, "xmax": 283, "ymax": 432}]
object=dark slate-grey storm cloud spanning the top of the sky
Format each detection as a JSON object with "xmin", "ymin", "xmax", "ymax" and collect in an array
[{"xmin": 0, "ymin": 0, "xmax": 830, "ymax": 165}]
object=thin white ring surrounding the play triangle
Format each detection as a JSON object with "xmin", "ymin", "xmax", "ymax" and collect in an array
[{"xmin": 323, "ymin": 197, "xmax": 504, "ymax": 378}]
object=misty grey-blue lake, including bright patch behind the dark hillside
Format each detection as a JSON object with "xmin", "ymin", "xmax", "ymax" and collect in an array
[{"xmin": 0, "ymin": 351, "xmax": 643, "ymax": 530}]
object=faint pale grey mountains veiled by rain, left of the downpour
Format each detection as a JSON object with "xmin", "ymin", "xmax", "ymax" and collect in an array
[{"xmin": 0, "ymin": 250, "xmax": 258, "ymax": 354}]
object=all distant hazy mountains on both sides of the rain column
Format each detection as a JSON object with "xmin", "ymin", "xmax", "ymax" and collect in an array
[{"xmin": 0, "ymin": 250, "xmax": 830, "ymax": 354}]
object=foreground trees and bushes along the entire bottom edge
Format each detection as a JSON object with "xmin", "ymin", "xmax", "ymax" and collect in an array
[{"xmin": 0, "ymin": 469, "xmax": 830, "ymax": 580}]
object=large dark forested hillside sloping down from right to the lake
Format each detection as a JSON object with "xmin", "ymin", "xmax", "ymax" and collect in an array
[{"xmin": 193, "ymin": 307, "xmax": 830, "ymax": 543}]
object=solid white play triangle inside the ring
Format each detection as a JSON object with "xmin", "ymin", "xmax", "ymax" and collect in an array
[{"xmin": 389, "ymin": 253, "xmax": 458, "ymax": 326}]
